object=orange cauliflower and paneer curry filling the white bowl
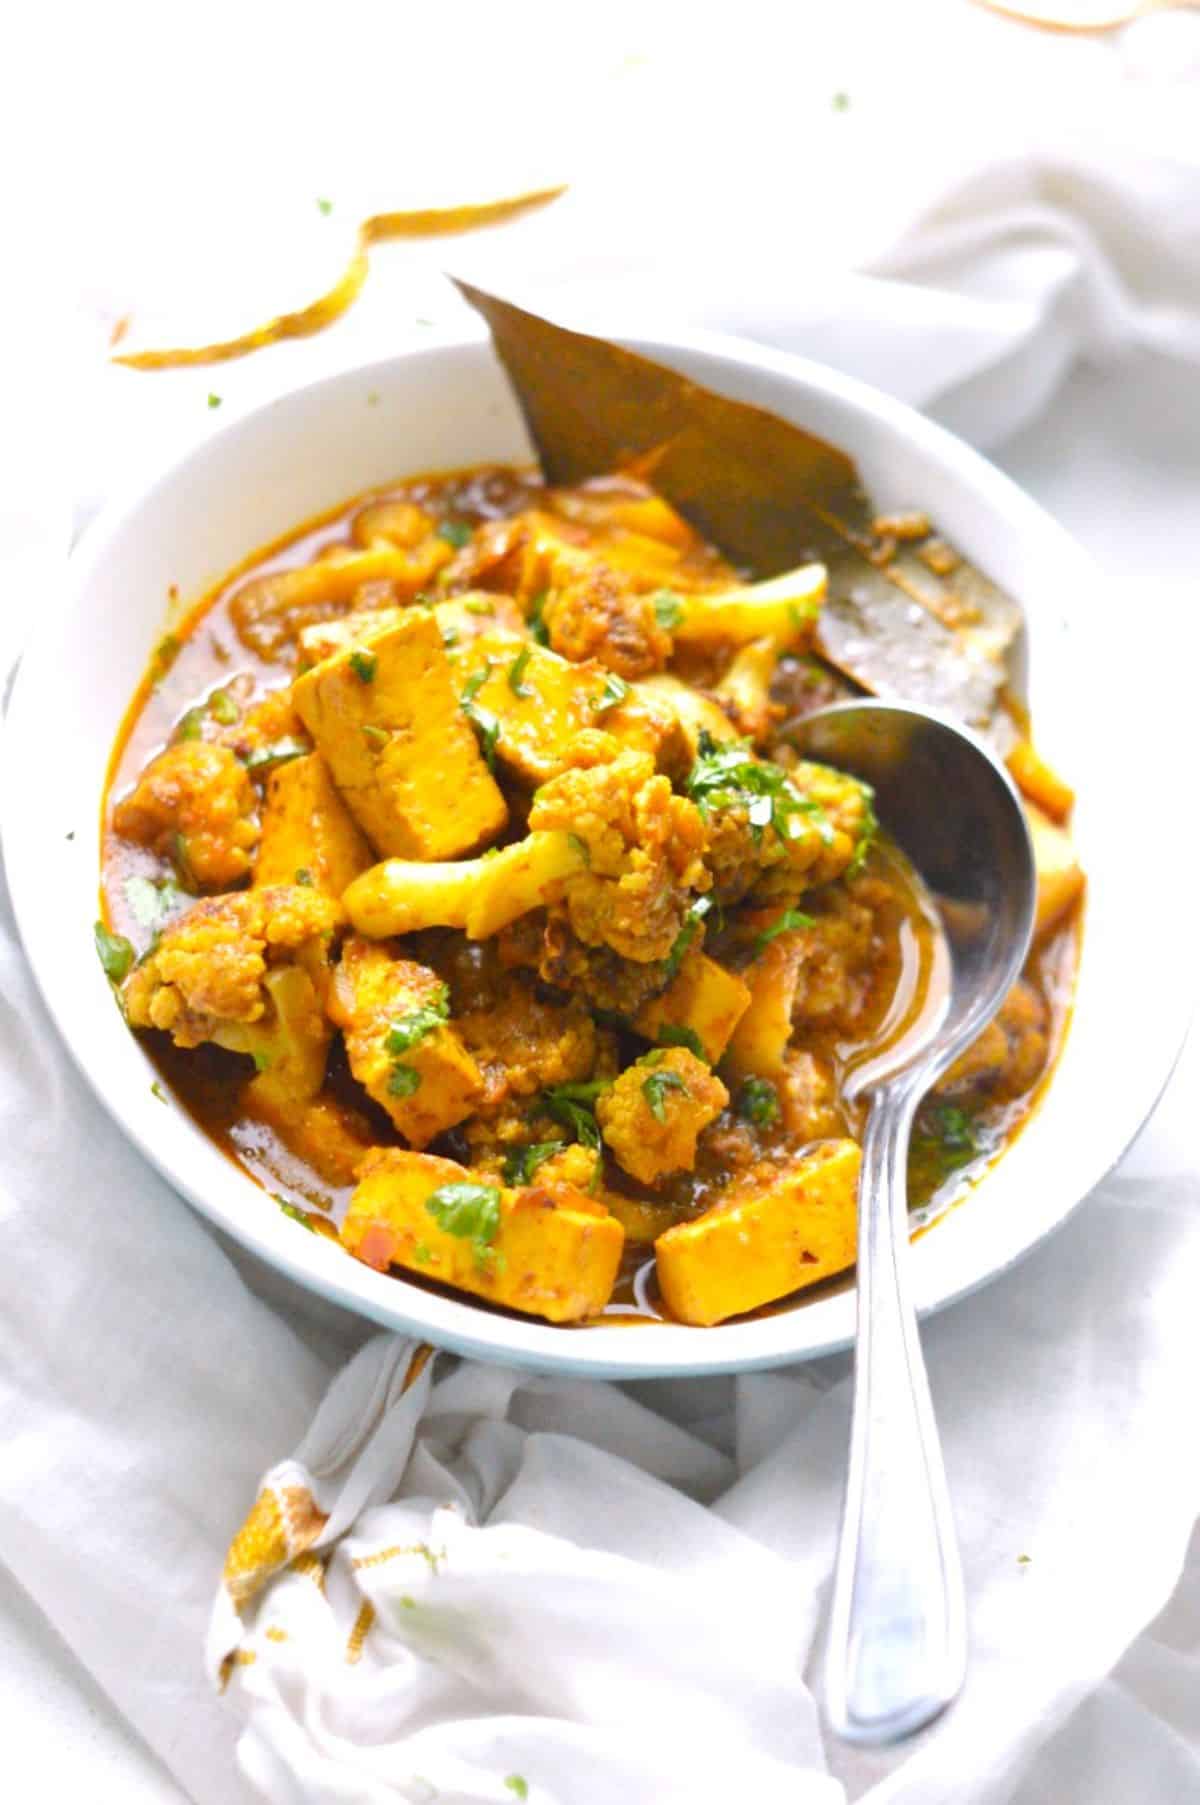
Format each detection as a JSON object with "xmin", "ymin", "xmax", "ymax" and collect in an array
[{"xmin": 97, "ymin": 451, "xmax": 1083, "ymax": 1325}]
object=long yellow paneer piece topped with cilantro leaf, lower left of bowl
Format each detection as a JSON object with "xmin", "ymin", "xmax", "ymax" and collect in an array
[{"xmin": 341, "ymin": 1148, "xmax": 624, "ymax": 1323}]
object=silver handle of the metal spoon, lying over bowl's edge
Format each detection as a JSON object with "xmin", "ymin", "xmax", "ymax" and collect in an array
[{"xmin": 825, "ymin": 1074, "xmax": 967, "ymax": 1744}]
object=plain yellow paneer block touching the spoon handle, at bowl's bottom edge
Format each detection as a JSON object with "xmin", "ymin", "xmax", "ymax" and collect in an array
[{"xmin": 655, "ymin": 1141, "xmax": 863, "ymax": 1327}]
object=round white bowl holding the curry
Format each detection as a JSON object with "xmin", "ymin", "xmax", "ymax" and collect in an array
[{"xmin": 4, "ymin": 334, "xmax": 1186, "ymax": 1377}]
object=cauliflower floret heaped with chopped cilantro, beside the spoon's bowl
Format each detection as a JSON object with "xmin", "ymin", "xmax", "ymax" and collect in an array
[{"xmin": 686, "ymin": 735, "xmax": 875, "ymax": 903}]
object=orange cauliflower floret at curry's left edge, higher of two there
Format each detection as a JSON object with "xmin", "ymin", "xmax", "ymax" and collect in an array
[{"xmin": 112, "ymin": 740, "xmax": 258, "ymax": 890}]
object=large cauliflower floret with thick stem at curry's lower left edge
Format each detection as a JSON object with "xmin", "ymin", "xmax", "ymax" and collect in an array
[{"xmin": 123, "ymin": 884, "xmax": 343, "ymax": 1112}]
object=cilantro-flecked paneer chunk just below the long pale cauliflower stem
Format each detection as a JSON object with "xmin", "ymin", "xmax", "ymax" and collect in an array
[{"xmin": 328, "ymin": 937, "xmax": 484, "ymax": 1146}]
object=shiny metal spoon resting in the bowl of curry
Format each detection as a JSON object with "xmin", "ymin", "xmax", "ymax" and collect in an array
[{"xmin": 785, "ymin": 702, "xmax": 1036, "ymax": 1744}]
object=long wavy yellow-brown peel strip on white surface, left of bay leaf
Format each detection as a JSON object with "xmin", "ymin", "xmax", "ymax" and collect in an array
[{"xmin": 112, "ymin": 182, "xmax": 567, "ymax": 370}]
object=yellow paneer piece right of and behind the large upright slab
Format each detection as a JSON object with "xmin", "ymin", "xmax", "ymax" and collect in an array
[{"xmin": 448, "ymin": 628, "xmax": 688, "ymax": 783}]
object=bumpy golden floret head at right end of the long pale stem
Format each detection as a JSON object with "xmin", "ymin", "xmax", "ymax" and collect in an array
[{"xmin": 529, "ymin": 735, "xmax": 709, "ymax": 964}]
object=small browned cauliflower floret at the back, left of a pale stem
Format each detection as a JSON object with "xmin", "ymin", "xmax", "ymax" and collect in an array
[{"xmin": 543, "ymin": 549, "xmax": 671, "ymax": 679}]
